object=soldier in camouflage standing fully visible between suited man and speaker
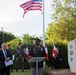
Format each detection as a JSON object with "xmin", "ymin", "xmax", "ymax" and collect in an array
[{"xmin": 15, "ymin": 43, "xmax": 24, "ymax": 72}]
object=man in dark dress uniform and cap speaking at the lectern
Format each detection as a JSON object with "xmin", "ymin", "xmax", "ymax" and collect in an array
[{"xmin": 29, "ymin": 38, "xmax": 46, "ymax": 75}]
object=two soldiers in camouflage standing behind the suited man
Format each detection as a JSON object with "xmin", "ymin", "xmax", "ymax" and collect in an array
[{"xmin": 7, "ymin": 43, "xmax": 28, "ymax": 72}]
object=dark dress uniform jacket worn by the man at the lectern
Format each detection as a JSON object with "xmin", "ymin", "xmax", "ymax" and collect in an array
[{"xmin": 30, "ymin": 45, "xmax": 46, "ymax": 68}]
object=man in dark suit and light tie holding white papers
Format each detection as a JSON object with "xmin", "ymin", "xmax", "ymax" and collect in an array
[{"xmin": 0, "ymin": 43, "xmax": 12, "ymax": 75}]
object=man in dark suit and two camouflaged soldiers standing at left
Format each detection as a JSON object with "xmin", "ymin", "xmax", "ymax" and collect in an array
[{"xmin": 0, "ymin": 43, "xmax": 27, "ymax": 75}]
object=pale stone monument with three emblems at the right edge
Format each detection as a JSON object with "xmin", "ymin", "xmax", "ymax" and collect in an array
[{"xmin": 68, "ymin": 39, "xmax": 76, "ymax": 72}]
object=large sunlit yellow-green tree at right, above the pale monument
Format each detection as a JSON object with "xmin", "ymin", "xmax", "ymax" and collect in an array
[{"xmin": 46, "ymin": 0, "xmax": 76, "ymax": 42}]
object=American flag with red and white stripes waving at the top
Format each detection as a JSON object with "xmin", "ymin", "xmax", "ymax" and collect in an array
[{"xmin": 20, "ymin": 0, "xmax": 42, "ymax": 17}]
